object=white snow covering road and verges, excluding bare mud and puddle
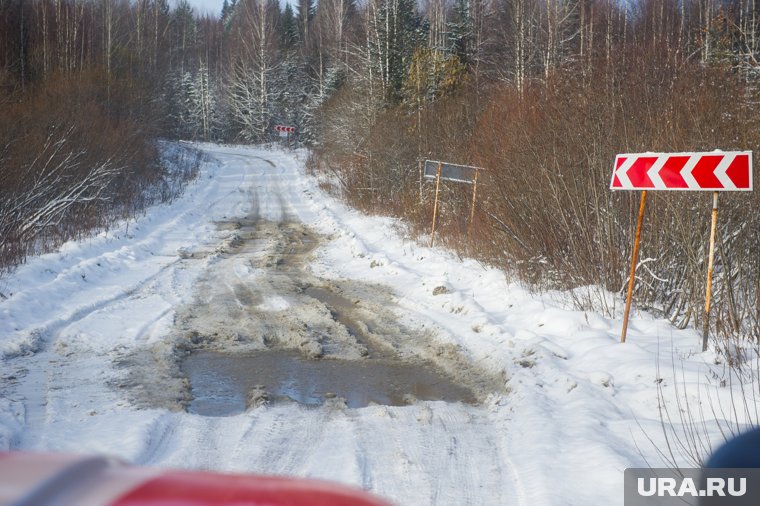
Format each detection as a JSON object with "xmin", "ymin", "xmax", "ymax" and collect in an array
[{"xmin": 0, "ymin": 145, "xmax": 754, "ymax": 506}]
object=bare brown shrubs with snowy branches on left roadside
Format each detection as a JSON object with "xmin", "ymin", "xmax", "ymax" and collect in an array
[{"xmin": 0, "ymin": 72, "xmax": 197, "ymax": 269}]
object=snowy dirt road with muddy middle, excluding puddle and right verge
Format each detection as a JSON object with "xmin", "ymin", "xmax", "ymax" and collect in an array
[{"xmin": 2, "ymin": 148, "xmax": 518, "ymax": 505}]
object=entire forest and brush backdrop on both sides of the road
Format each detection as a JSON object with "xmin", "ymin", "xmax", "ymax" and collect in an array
[{"xmin": 0, "ymin": 0, "xmax": 760, "ymax": 340}]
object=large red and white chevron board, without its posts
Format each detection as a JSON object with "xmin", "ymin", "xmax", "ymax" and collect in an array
[{"xmin": 610, "ymin": 151, "xmax": 752, "ymax": 191}]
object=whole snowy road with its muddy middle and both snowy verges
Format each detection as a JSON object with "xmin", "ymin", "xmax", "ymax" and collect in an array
[{"xmin": 0, "ymin": 145, "xmax": 730, "ymax": 506}]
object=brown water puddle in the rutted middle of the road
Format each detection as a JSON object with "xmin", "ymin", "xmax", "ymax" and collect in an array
[{"xmin": 182, "ymin": 350, "xmax": 477, "ymax": 416}]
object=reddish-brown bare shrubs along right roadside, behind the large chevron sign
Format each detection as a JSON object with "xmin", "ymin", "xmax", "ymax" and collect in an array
[{"xmin": 314, "ymin": 47, "xmax": 760, "ymax": 344}]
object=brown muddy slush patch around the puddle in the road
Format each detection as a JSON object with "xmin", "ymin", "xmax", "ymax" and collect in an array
[{"xmin": 114, "ymin": 217, "xmax": 504, "ymax": 413}]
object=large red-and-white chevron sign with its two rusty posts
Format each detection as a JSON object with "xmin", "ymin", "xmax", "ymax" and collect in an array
[{"xmin": 610, "ymin": 151, "xmax": 752, "ymax": 351}]
